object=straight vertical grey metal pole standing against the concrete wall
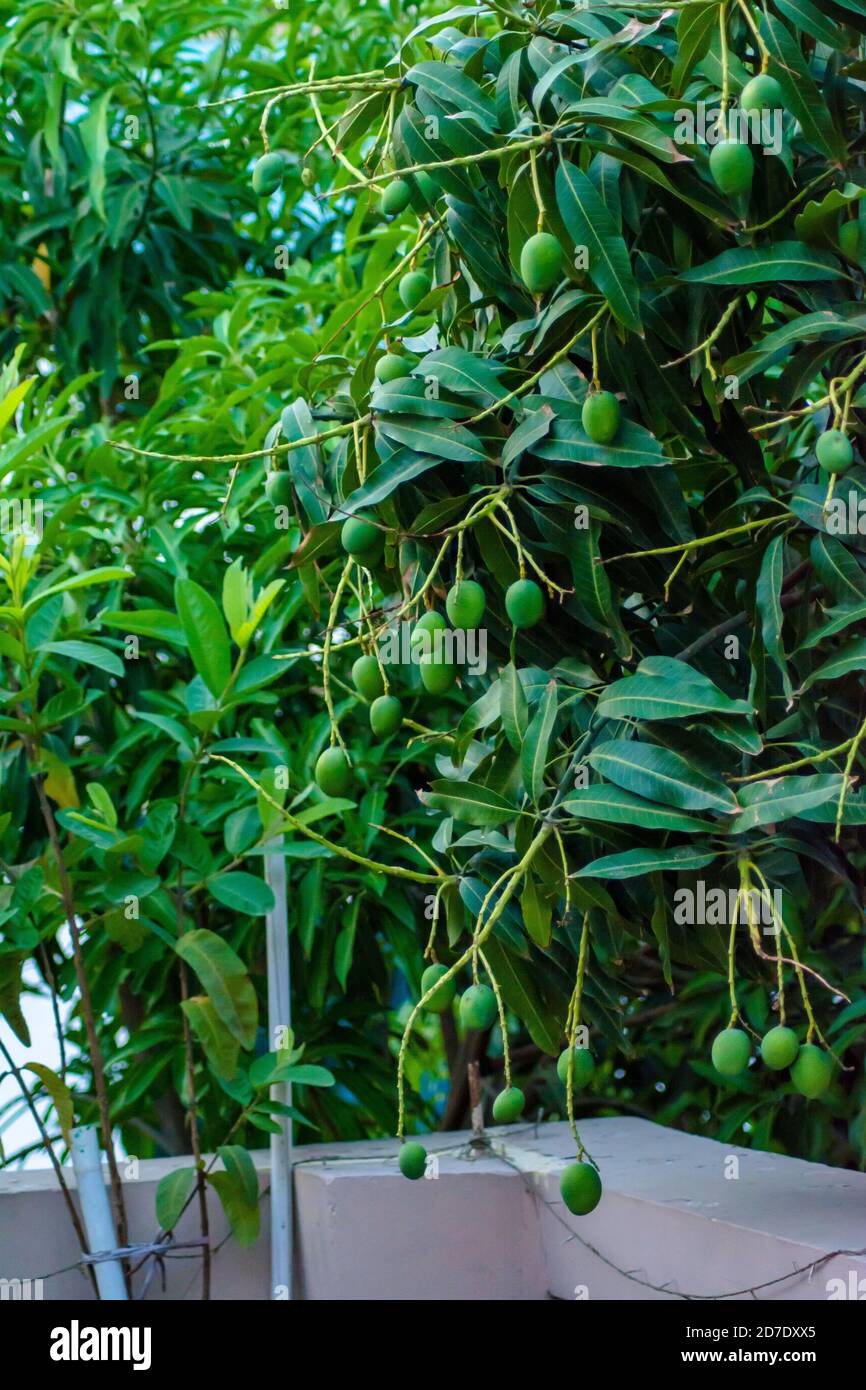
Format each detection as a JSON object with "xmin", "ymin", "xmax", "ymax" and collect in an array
[{"xmin": 264, "ymin": 835, "xmax": 292, "ymax": 1300}]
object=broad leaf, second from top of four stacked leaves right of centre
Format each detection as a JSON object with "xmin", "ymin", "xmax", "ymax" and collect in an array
[{"xmin": 588, "ymin": 738, "xmax": 737, "ymax": 816}]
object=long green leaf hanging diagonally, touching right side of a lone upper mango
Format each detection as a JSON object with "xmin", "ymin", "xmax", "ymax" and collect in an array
[{"xmin": 556, "ymin": 160, "xmax": 644, "ymax": 334}]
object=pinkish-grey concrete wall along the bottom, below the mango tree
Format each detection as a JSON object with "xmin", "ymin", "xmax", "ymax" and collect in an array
[{"xmin": 0, "ymin": 1118, "xmax": 866, "ymax": 1301}]
